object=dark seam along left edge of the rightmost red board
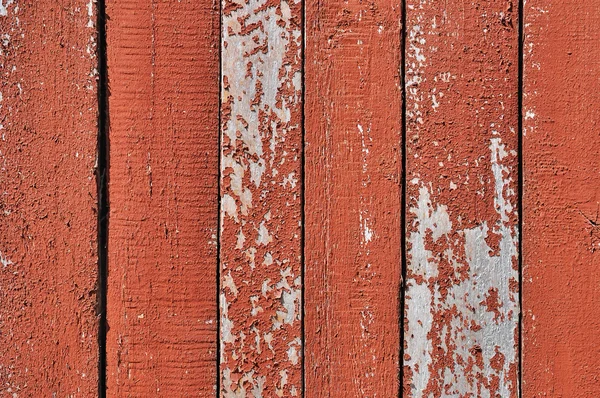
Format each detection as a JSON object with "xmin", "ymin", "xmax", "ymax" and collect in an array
[{"xmin": 517, "ymin": 0, "xmax": 524, "ymax": 397}]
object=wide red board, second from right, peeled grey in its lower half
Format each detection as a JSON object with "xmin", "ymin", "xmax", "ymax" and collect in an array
[{"xmin": 404, "ymin": 0, "xmax": 519, "ymax": 397}]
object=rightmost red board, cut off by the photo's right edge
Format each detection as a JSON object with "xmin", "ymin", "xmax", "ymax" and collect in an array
[{"xmin": 523, "ymin": 0, "xmax": 600, "ymax": 397}]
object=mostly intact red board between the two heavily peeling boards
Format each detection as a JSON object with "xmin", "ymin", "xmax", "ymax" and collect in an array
[{"xmin": 305, "ymin": 0, "xmax": 402, "ymax": 397}]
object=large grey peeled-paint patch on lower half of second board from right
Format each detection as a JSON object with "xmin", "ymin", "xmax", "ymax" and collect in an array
[{"xmin": 405, "ymin": 138, "xmax": 519, "ymax": 397}]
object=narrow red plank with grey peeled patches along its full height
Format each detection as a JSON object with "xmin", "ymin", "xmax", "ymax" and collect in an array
[{"xmin": 220, "ymin": 0, "xmax": 302, "ymax": 397}]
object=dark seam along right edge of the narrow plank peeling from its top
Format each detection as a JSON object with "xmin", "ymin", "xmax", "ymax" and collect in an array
[{"xmin": 300, "ymin": 0, "xmax": 306, "ymax": 397}]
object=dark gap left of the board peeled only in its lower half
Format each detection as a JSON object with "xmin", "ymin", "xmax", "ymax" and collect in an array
[{"xmin": 398, "ymin": 0, "xmax": 407, "ymax": 397}]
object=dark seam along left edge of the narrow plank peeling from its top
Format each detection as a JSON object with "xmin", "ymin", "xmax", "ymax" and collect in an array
[{"xmin": 215, "ymin": 0, "xmax": 223, "ymax": 398}]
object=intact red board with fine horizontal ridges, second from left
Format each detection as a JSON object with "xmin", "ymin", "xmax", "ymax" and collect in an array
[{"xmin": 107, "ymin": 0, "xmax": 219, "ymax": 397}]
